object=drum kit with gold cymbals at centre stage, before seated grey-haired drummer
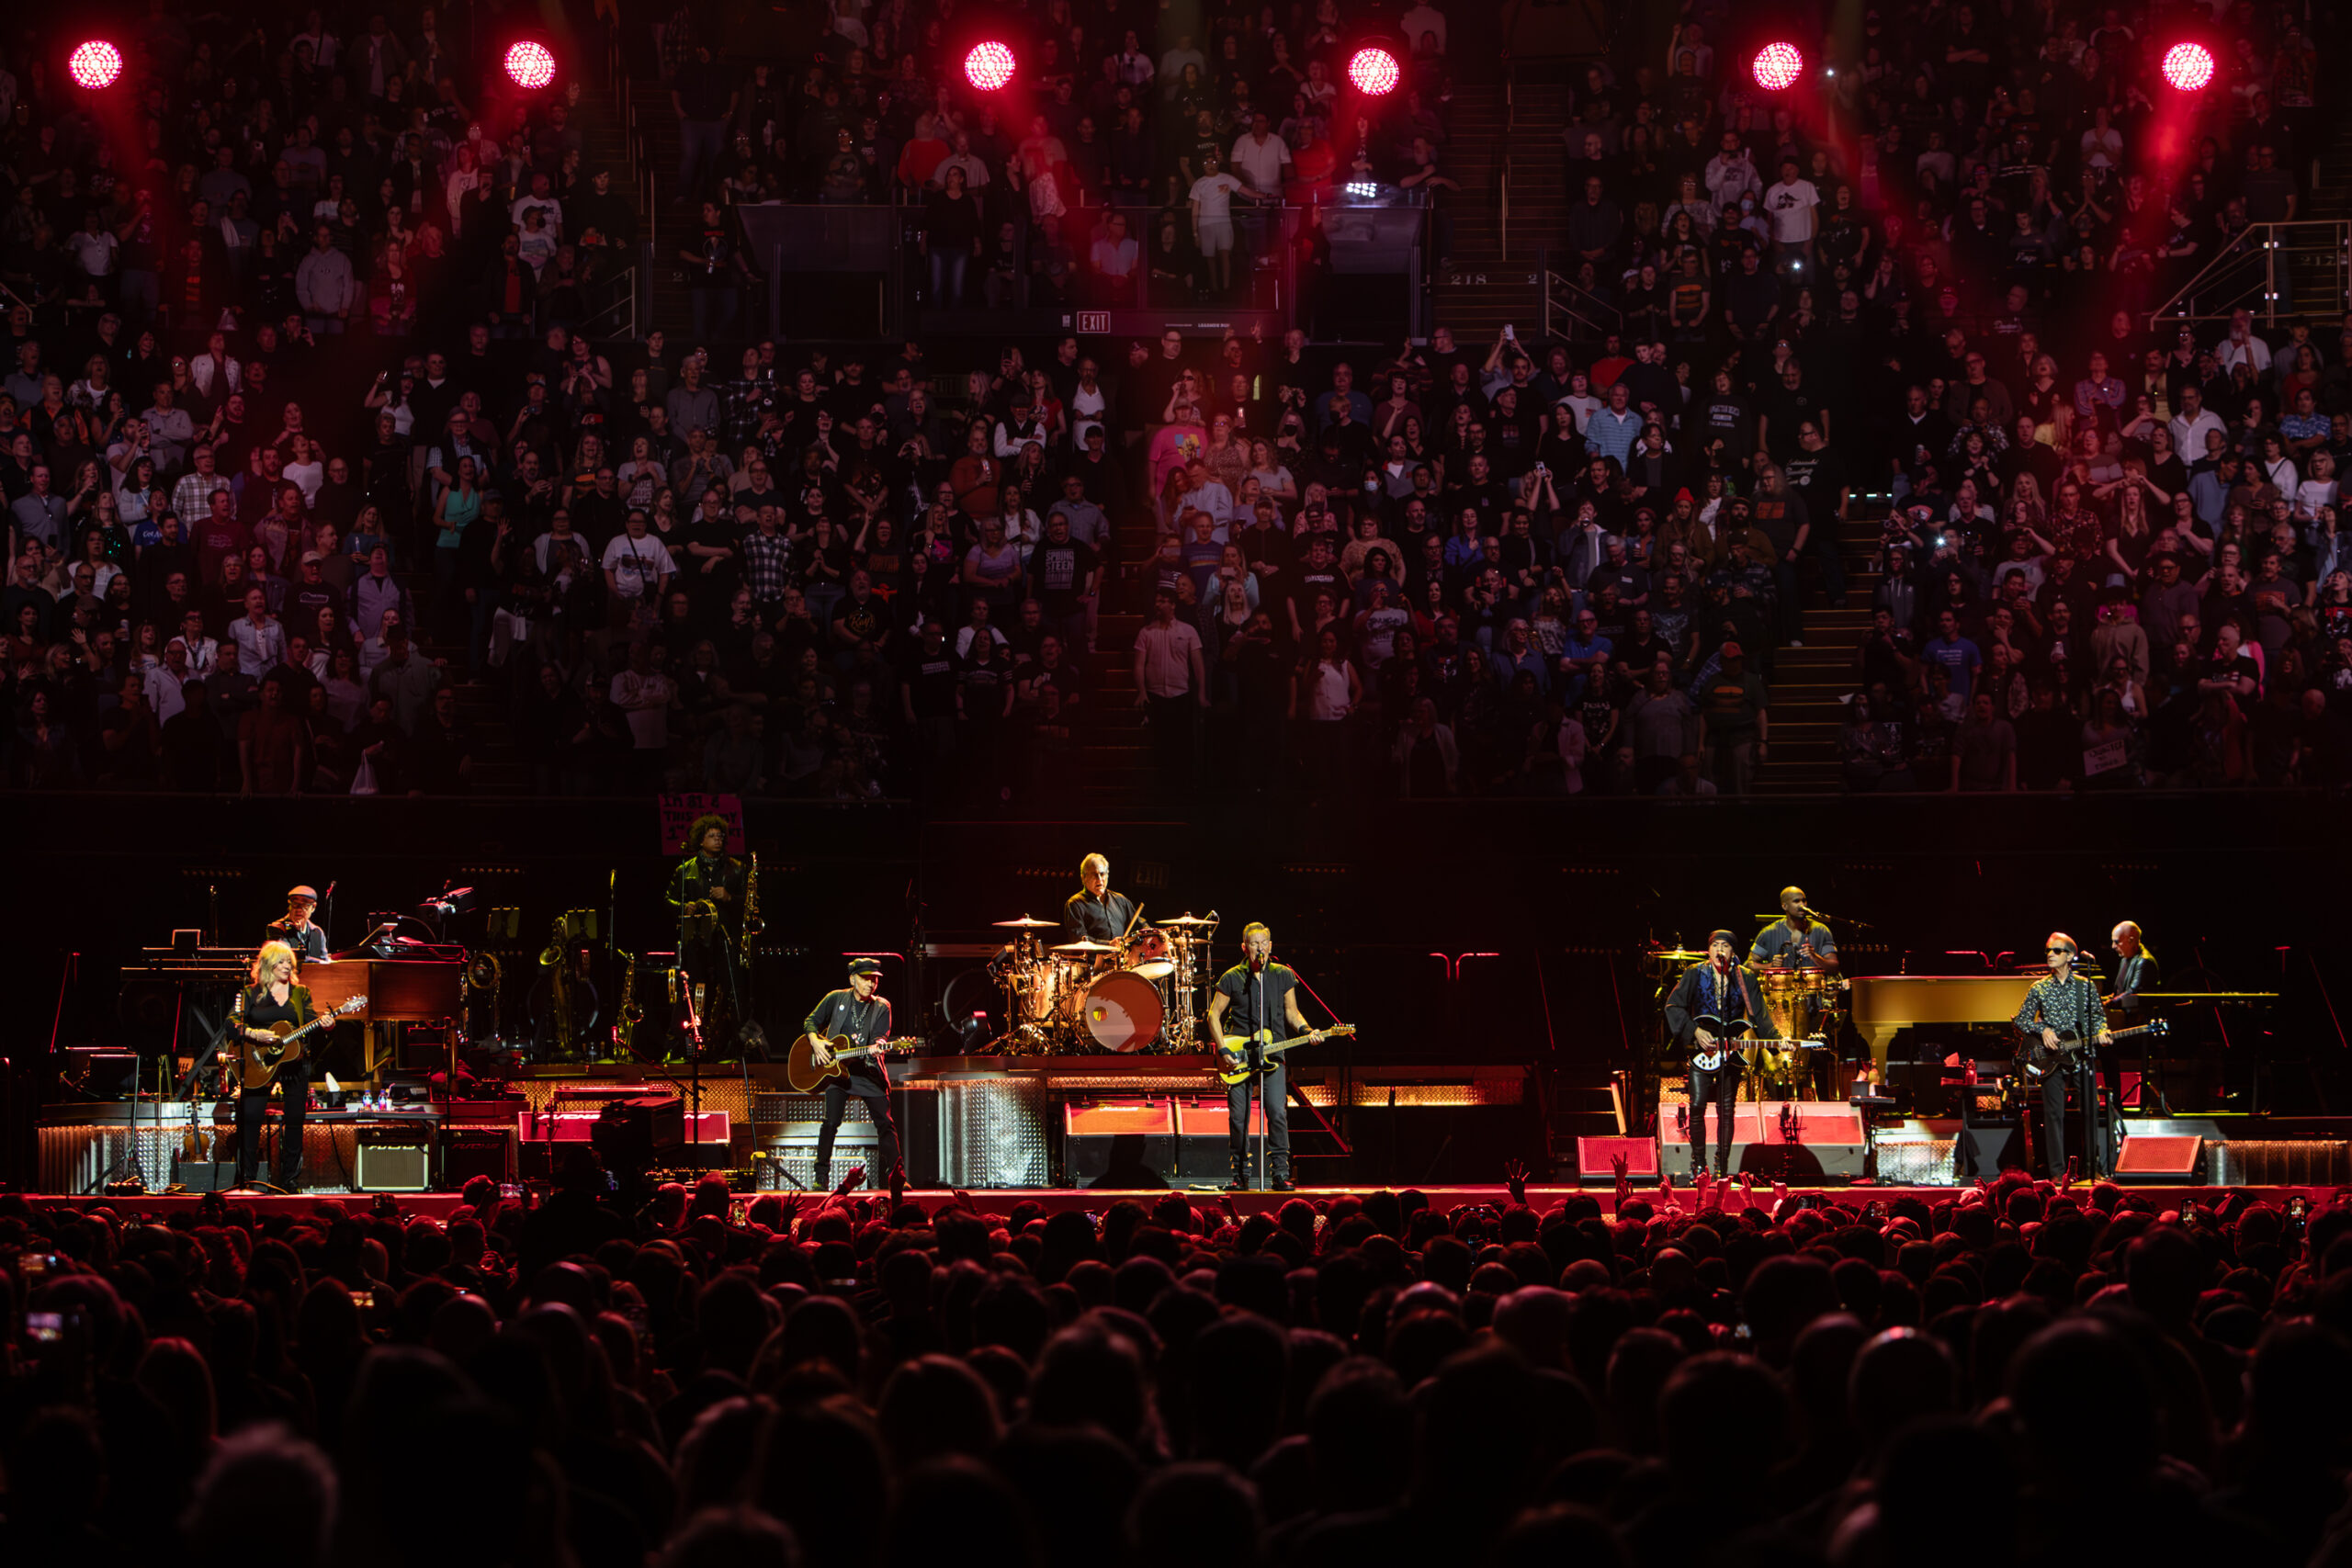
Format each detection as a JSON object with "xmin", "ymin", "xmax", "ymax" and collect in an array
[{"xmin": 988, "ymin": 915, "xmax": 1216, "ymax": 1055}]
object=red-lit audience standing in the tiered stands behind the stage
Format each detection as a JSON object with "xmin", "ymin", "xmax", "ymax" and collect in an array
[{"xmin": 0, "ymin": 0, "xmax": 2352, "ymax": 804}]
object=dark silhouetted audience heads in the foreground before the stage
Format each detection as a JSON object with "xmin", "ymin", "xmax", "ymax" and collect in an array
[{"xmin": 0, "ymin": 1166, "xmax": 2352, "ymax": 1568}]
